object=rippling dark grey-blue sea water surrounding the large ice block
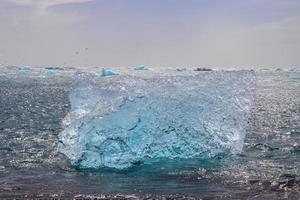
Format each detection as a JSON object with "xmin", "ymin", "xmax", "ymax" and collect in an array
[{"xmin": 0, "ymin": 68, "xmax": 300, "ymax": 199}]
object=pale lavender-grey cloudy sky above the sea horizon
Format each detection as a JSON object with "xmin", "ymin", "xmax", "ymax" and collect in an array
[{"xmin": 0, "ymin": 0, "xmax": 300, "ymax": 68}]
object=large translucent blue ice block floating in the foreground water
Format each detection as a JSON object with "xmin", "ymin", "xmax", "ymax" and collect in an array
[{"xmin": 59, "ymin": 71, "xmax": 255, "ymax": 169}]
